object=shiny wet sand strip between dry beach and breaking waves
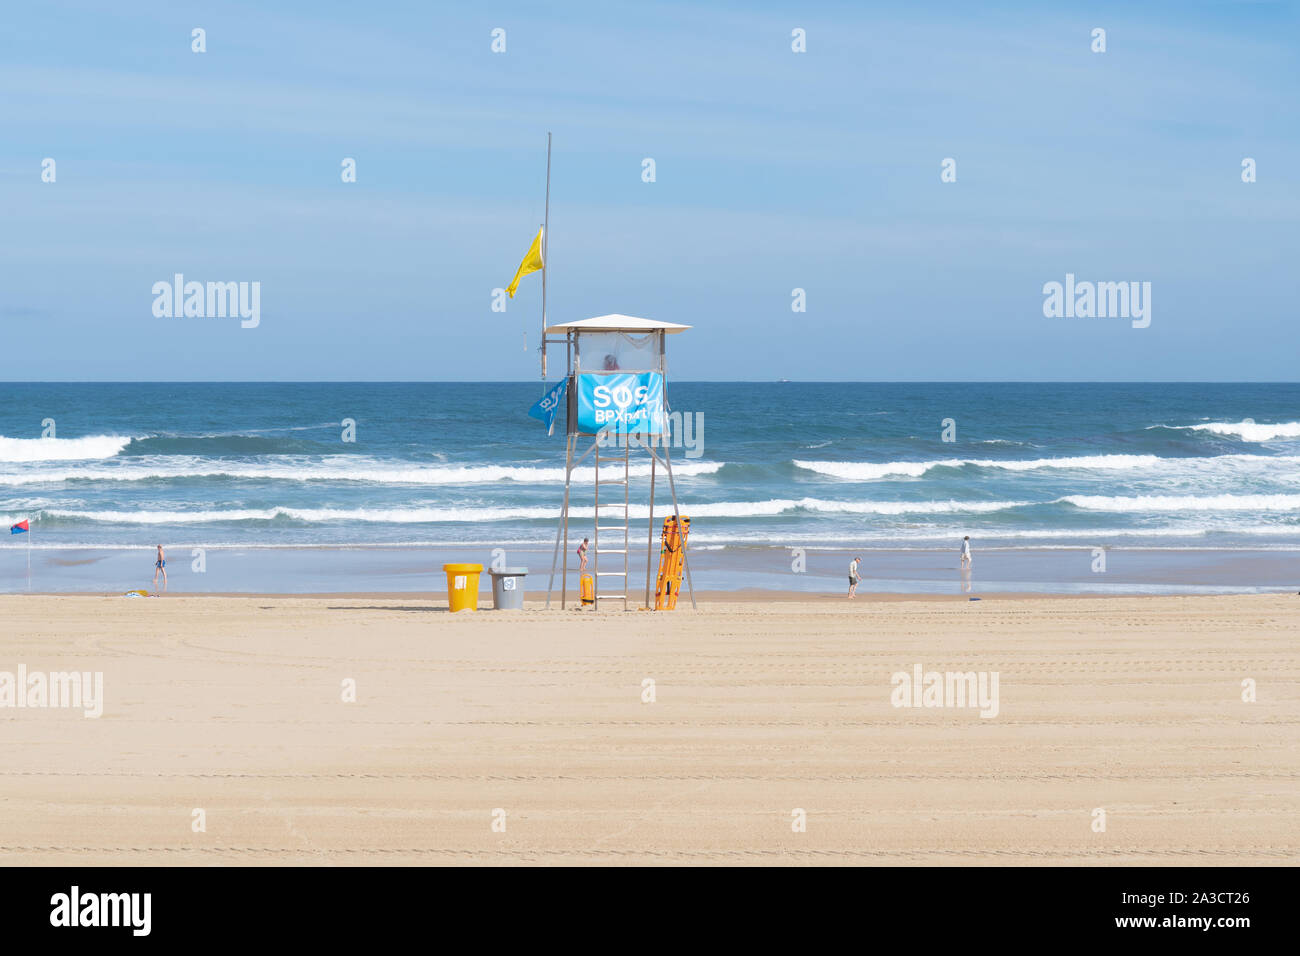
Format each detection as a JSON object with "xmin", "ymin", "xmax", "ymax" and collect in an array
[{"xmin": 0, "ymin": 541, "xmax": 1300, "ymax": 597}]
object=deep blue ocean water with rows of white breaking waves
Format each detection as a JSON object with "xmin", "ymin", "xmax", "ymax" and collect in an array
[{"xmin": 0, "ymin": 381, "xmax": 1300, "ymax": 591}]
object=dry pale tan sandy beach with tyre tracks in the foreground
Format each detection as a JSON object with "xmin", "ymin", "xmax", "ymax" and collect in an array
[{"xmin": 0, "ymin": 593, "xmax": 1300, "ymax": 866}]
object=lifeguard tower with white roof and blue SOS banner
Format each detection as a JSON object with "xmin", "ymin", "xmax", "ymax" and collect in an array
[{"xmin": 542, "ymin": 315, "xmax": 696, "ymax": 610}]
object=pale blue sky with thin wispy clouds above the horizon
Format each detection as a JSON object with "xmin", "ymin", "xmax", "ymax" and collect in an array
[{"xmin": 0, "ymin": 0, "xmax": 1300, "ymax": 381}]
